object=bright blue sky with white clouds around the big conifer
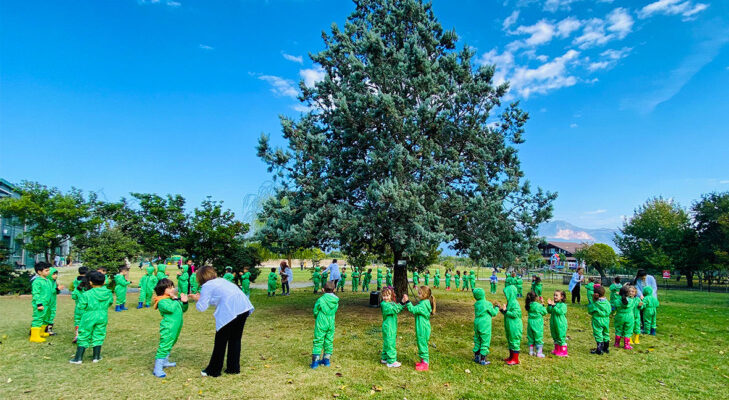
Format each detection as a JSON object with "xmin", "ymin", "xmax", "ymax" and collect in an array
[{"xmin": 0, "ymin": 0, "xmax": 729, "ymax": 228}]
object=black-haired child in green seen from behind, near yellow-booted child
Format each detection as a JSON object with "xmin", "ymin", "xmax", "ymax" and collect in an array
[{"xmin": 70, "ymin": 271, "xmax": 114, "ymax": 364}]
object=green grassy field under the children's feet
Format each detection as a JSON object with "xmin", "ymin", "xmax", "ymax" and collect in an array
[{"xmin": 0, "ymin": 268, "xmax": 729, "ymax": 400}]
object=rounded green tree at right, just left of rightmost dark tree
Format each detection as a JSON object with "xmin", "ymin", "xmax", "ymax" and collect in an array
[{"xmin": 615, "ymin": 197, "xmax": 700, "ymax": 287}]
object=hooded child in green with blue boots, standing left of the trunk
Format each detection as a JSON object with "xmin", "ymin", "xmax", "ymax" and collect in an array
[{"xmin": 310, "ymin": 281, "xmax": 339, "ymax": 369}]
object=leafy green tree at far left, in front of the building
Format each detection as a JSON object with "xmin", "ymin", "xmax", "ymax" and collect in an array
[{"xmin": 0, "ymin": 181, "xmax": 101, "ymax": 263}]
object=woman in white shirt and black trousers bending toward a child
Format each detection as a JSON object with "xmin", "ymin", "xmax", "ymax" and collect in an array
[{"xmin": 190, "ymin": 265, "xmax": 253, "ymax": 377}]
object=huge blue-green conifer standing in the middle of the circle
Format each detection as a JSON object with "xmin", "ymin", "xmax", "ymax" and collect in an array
[{"xmin": 258, "ymin": 0, "xmax": 555, "ymax": 295}]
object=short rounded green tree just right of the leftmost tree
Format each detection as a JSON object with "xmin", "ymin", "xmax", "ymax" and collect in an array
[{"xmin": 81, "ymin": 227, "xmax": 141, "ymax": 275}]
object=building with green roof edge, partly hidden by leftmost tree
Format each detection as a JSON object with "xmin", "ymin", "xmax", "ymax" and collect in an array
[{"xmin": 0, "ymin": 178, "xmax": 70, "ymax": 269}]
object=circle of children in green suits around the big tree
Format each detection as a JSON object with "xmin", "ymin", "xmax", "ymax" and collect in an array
[{"xmin": 25, "ymin": 262, "xmax": 658, "ymax": 377}]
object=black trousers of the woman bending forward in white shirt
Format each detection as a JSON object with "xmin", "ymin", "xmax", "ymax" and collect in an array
[{"xmin": 205, "ymin": 311, "xmax": 249, "ymax": 376}]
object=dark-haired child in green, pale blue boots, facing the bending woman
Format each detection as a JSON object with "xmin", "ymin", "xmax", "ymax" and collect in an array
[{"xmin": 153, "ymin": 279, "xmax": 188, "ymax": 378}]
